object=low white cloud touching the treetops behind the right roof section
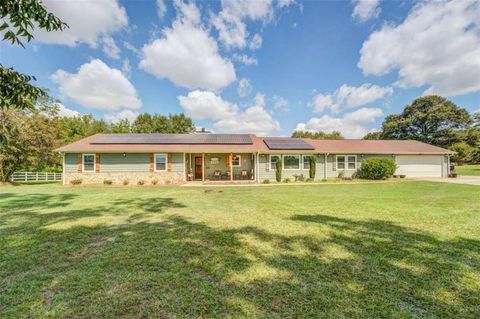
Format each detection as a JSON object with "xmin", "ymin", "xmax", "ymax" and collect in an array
[{"xmin": 295, "ymin": 108, "xmax": 383, "ymax": 138}]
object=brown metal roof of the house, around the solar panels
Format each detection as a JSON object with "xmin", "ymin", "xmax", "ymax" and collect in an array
[{"xmin": 55, "ymin": 134, "xmax": 454, "ymax": 154}]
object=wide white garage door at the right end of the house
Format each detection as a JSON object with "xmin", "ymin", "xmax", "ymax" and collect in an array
[{"xmin": 395, "ymin": 155, "xmax": 443, "ymax": 177}]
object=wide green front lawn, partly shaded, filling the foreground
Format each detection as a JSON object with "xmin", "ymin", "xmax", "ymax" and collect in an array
[{"xmin": 0, "ymin": 181, "xmax": 480, "ymax": 318}]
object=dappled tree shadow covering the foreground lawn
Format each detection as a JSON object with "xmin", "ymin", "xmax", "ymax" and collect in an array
[{"xmin": 0, "ymin": 191, "xmax": 480, "ymax": 318}]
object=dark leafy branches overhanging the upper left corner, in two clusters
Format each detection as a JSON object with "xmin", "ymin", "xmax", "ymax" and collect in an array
[{"xmin": 0, "ymin": 0, "xmax": 68, "ymax": 109}]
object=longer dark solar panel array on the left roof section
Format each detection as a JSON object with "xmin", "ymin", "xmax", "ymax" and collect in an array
[{"xmin": 91, "ymin": 133, "xmax": 253, "ymax": 144}]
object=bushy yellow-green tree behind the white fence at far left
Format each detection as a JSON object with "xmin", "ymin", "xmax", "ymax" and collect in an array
[{"xmin": 0, "ymin": 107, "xmax": 61, "ymax": 182}]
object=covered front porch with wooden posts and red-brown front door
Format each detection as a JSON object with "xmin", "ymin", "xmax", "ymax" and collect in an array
[{"xmin": 185, "ymin": 153, "xmax": 256, "ymax": 184}]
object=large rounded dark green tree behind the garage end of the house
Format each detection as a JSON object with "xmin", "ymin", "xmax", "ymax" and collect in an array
[{"xmin": 381, "ymin": 95, "xmax": 472, "ymax": 147}]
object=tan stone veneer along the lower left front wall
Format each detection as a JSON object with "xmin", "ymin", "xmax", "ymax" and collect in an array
[{"xmin": 65, "ymin": 172, "xmax": 184, "ymax": 185}]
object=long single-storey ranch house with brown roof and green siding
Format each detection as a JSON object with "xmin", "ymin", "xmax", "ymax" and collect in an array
[{"xmin": 56, "ymin": 134, "xmax": 453, "ymax": 184}]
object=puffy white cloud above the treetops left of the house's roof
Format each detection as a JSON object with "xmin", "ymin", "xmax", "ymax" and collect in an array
[{"xmin": 52, "ymin": 59, "xmax": 142, "ymax": 110}]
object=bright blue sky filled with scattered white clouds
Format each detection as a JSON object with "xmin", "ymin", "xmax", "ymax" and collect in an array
[{"xmin": 0, "ymin": 0, "xmax": 480, "ymax": 138}]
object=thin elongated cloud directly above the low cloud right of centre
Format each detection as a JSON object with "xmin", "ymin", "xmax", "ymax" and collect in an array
[{"xmin": 310, "ymin": 83, "xmax": 393, "ymax": 113}]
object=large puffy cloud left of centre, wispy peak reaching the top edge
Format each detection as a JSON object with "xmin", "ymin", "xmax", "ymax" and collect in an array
[{"xmin": 140, "ymin": 2, "xmax": 236, "ymax": 91}]
